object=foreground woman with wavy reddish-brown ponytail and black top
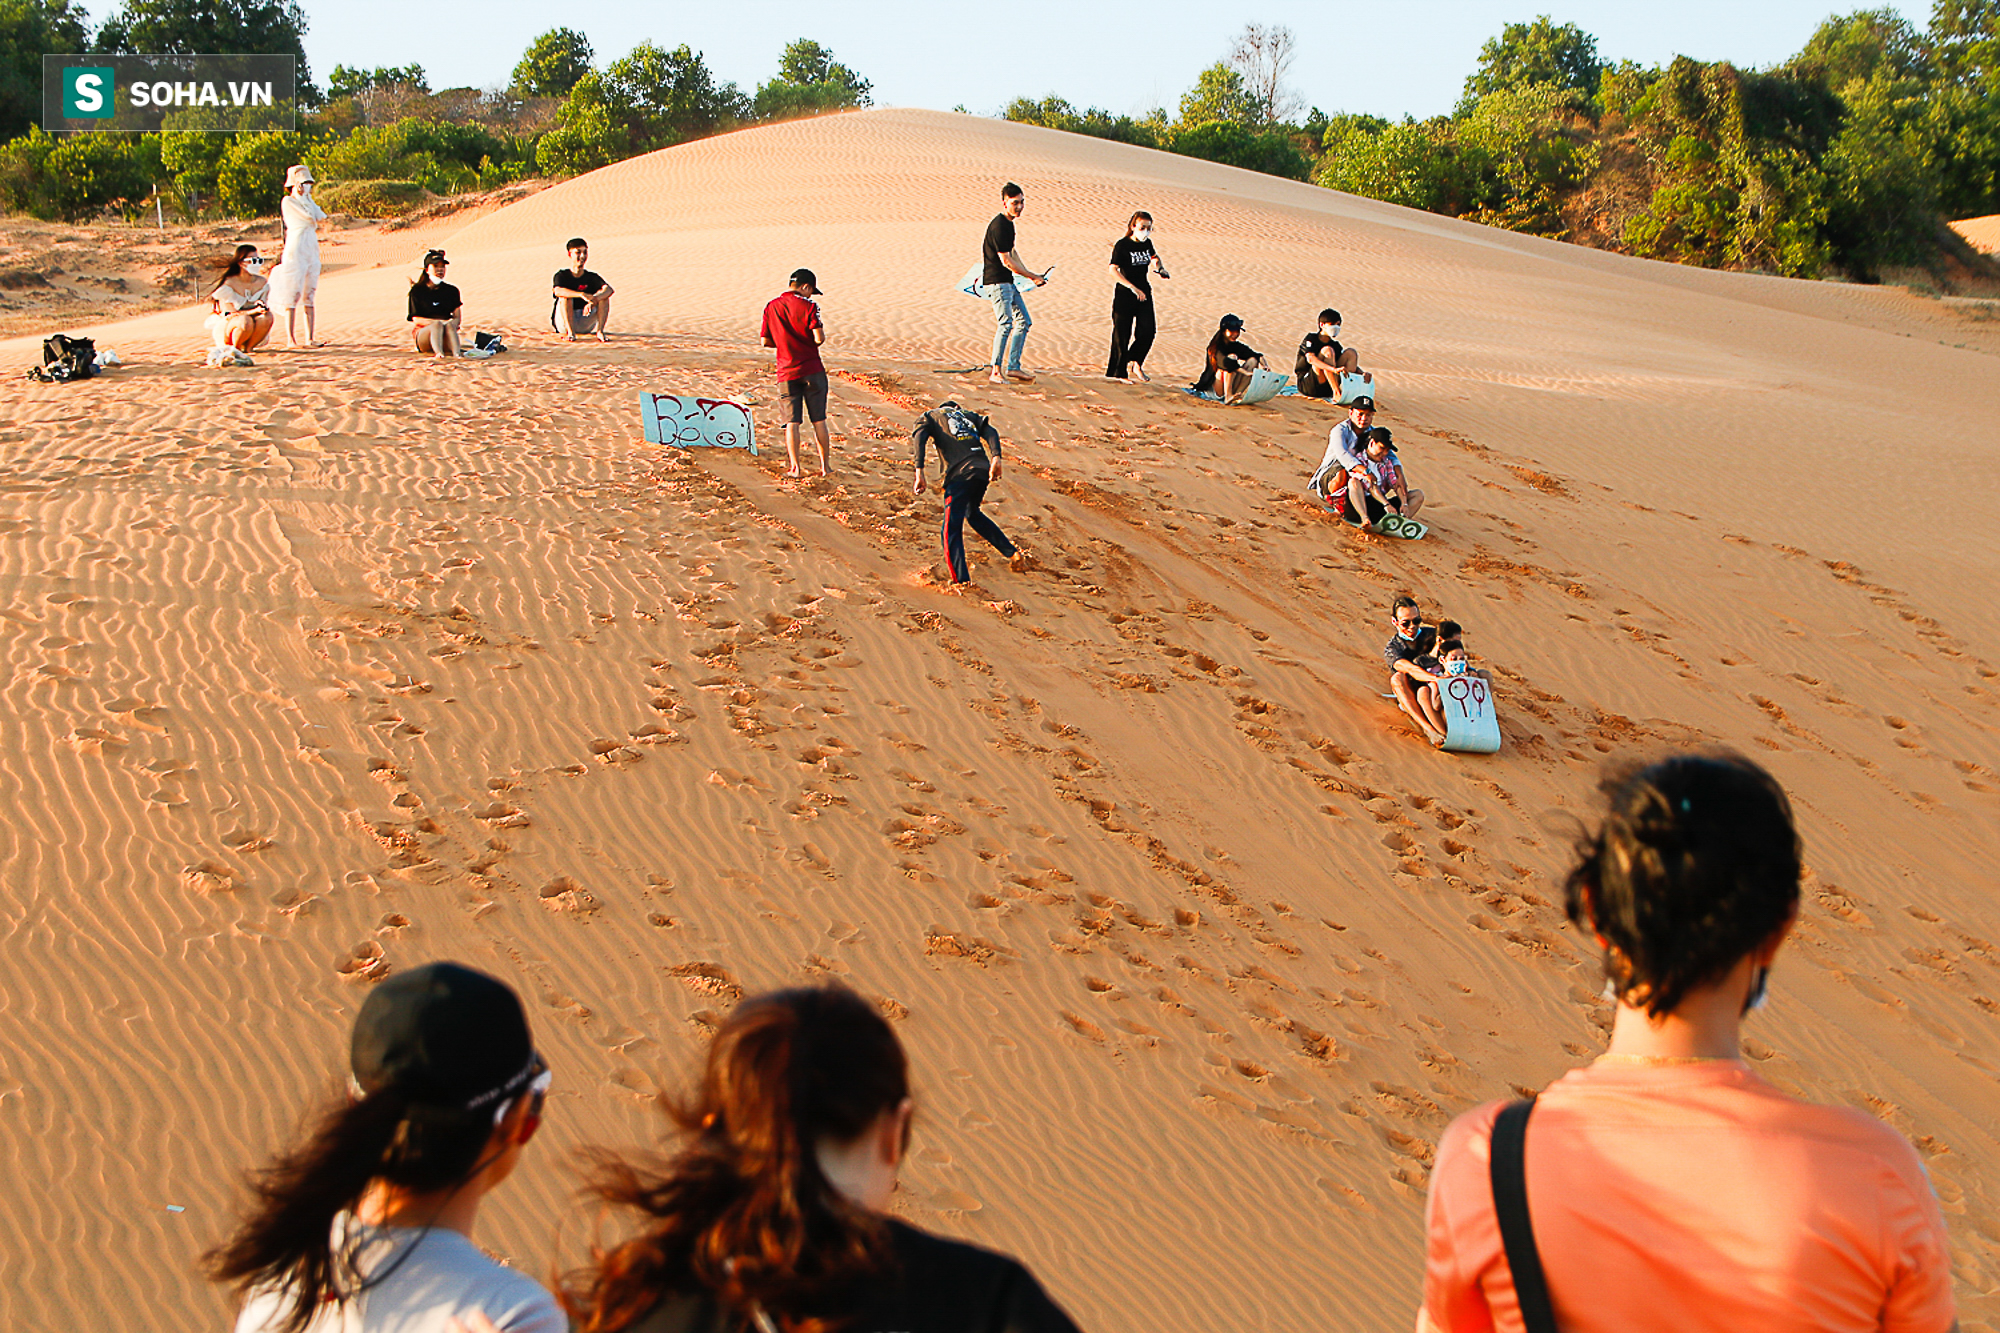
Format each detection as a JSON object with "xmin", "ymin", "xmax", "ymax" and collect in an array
[{"xmin": 572, "ymin": 987, "xmax": 1076, "ymax": 1333}]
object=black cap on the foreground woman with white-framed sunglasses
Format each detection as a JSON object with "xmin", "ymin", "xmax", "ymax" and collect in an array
[{"xmin": 350, "ymin": 963, "xmax": 534, "ymax": 1111}]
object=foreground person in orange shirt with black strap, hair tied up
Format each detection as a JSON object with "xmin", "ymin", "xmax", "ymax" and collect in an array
[{"xmin": 1418, "ymin": 755, "xmax": 1958, "ymax": 1333}]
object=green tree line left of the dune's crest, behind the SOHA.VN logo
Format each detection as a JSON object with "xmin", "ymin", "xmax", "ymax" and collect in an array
[{"xmin": 0, "ymin": 0, "xmax": 872, "ymax": 220}]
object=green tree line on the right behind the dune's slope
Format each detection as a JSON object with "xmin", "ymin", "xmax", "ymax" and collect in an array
[{"xmin": 1006, "ymin": 9, "xmax": 2000, "ymax": 282}]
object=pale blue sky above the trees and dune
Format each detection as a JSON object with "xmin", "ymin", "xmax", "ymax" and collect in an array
[{"xmin": 88, "ymin": 0, "xmax": 1930, "ymax": 118}]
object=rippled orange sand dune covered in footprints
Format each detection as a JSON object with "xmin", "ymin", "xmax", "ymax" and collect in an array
[{"xmin": 0, "ymin": 112, "xmax": 2000, "ymax": 1331}]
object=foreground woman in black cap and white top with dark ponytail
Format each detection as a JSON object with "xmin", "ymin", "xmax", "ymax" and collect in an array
[{"xmin": 206, "ymin": 963, "xmax": 568, "ymax": 1333}]
